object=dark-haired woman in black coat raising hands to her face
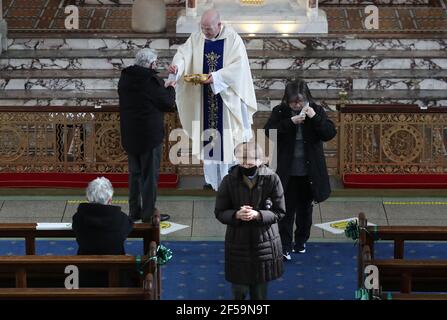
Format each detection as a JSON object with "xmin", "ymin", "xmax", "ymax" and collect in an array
[{"xmin": 264, "ymin": 80, "xmax": 337, "ymax": 260}]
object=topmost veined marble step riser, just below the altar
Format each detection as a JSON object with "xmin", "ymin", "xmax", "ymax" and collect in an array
[{"xmin": 8, "ymin": 37, "xmax": 447, "ymax": 52}]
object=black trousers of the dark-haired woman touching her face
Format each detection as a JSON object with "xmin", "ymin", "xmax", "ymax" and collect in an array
[{"xmin": 279, "ymin": 176, "xmax": 313, "ymax": 252}]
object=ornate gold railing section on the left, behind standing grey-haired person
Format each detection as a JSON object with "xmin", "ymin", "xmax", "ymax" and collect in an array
[{"xmin": 0, "ymin": 106, "xmax": 179, "ymax": 173}]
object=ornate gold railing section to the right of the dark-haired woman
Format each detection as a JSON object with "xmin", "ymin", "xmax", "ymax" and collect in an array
[{"xmin": 339, "ymin": 105, "xmax": 447, "ymax": 175}]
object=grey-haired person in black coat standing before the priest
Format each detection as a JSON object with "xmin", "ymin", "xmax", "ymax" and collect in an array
[{"xmin": 118, "ymin": 48, "xmax": 176, "ymax": 222}]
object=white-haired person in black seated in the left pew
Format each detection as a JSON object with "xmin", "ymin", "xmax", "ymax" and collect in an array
[{"xmin": 72, "ymin": 177, "xmax": 133, "ymax": 287}]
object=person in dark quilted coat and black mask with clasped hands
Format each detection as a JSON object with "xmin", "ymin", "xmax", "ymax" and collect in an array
[{"xmin": 214, "ymin": 143, "xmax": 285, "ymax": 300}]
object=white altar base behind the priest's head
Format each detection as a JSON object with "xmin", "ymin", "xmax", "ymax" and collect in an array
[{"xmin": 176, "ymin": 0, "xmax": 328, "ymax": 35}]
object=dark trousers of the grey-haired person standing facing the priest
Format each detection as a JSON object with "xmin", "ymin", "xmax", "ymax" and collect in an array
[{"xmin": 128, "ymin": 145, "xmax": 162, "ymax": 222}]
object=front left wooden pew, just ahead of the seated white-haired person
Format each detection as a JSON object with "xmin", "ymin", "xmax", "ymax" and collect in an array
[{"xmin": 0, "ymin": 215, "xmax": 161, "ymax": 298}]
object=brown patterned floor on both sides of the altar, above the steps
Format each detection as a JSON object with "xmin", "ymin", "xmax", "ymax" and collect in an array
[{"xmin": 3, "ymin": 0, "xmax": 447, "ymax": 34}]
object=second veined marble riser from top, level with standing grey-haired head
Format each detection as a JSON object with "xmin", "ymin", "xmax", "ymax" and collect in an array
[{"xmin": 0, "ymin": 56, "xmax": 447, "ymax": 70}]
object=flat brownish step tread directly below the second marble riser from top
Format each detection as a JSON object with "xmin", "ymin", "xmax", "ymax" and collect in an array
[{"xmin": 0, "ymin": 69, "xmax": 447, "ymax": 80}]
